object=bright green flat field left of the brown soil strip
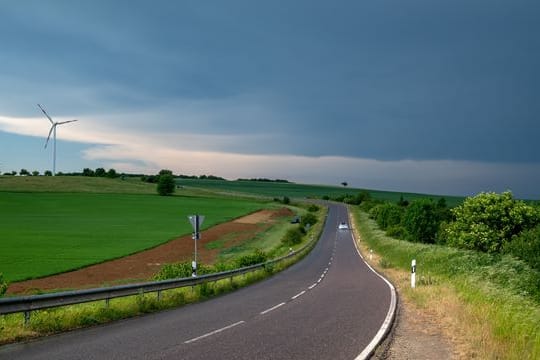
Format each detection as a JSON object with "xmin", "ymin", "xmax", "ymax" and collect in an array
[{"xmin": 0, "ymin": 192, "xmax": 264, "ymax": 281}]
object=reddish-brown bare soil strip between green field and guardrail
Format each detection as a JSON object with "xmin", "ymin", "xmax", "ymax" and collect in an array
[{"xmin": 8, "ymin": 208, "xmax": 293, "ymax": 294}]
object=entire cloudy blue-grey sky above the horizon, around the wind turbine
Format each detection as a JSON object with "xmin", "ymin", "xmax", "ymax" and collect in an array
[{"xmin": 0, "ymin": 0, "xmax": 540, "ymax": 198}]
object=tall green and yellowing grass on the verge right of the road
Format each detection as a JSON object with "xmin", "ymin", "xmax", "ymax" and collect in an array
[{"xmin": 353, "ymin": 209, "xmax": 540, "ymax": 359}]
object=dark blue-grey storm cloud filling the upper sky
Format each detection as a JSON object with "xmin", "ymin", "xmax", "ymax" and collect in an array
[{"xmin": 0, "ymin": 0, "xmax": 540, "ymax": 163}]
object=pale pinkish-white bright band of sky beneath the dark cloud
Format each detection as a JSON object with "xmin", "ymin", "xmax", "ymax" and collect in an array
[{"xmin": 0, "ymin": 117, "xmax": 540, "ymax": 197}]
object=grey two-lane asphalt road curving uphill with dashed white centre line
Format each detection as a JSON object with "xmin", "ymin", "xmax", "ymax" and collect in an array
[{"xmin": 0, "ymin": 205, "xmax": 391, "ymax": 360}]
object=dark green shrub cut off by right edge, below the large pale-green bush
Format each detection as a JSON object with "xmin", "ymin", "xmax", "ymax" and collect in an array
[{"xmin": 503, "ymin": 225, "xmax": 540, "ymax": 270}]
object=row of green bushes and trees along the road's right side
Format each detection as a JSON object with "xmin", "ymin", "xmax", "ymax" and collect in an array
[{"xmin": 339, "ymin": 191, "xmax": 540, "ymax": 270}]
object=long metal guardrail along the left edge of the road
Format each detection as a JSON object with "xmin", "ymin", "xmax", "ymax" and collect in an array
[{"xmin": 0, "ymin": 239, "xmax": 315, "ymax": 323}]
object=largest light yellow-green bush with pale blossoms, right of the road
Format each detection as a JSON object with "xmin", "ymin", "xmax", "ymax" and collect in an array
[{"xmin": 445, "ymin": 191, "xmax": 540, "ymax": 253}]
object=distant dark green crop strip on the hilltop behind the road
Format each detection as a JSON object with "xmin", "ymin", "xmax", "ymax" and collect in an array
[{"xmin": 177, "ymin": 179, "xmax": 463, "ymax": 206}]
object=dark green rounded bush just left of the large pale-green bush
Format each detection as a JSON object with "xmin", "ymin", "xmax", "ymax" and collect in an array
[{"xmin": 402, "ymin": 199, "xmax": 440, "ymax": 244}]
